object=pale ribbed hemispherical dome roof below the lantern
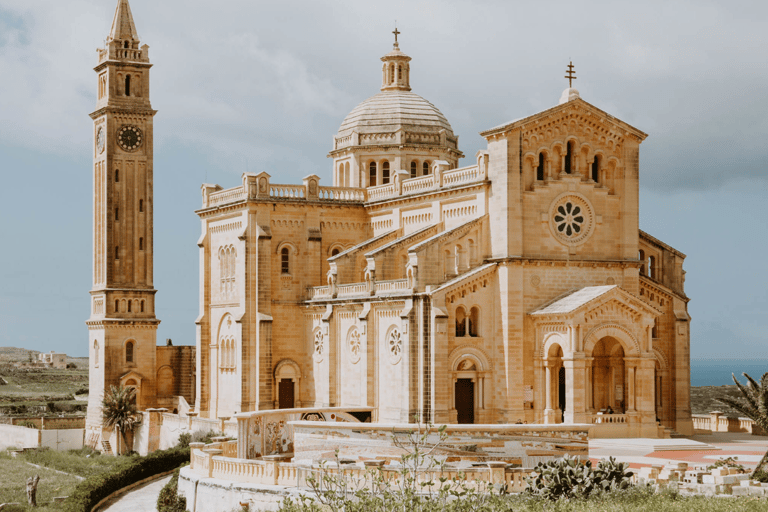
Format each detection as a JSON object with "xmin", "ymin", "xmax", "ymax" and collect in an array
[{"xmin": 338, "ymin": 89, "xmax": 453, "ymax": 138}]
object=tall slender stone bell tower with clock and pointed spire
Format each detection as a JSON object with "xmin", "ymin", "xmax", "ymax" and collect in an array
[{"xmin": 86, "ymin": 0, "xmax": 160, "ymax": 449}]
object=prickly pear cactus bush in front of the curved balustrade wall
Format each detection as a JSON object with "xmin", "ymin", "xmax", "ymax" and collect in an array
[{"xmin": 526, "ymin": 455, "xmax": 632, "ymax": 500}]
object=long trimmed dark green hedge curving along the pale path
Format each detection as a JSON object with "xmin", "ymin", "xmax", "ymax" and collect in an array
[{"xmin": 63, "ymin": 448, "xmax": 189, "ymax": 512}]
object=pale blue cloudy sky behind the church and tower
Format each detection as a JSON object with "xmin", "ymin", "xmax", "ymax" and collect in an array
[{"xmin": 0, "ymin": 0, "xmax": 768, "ymax": 368}]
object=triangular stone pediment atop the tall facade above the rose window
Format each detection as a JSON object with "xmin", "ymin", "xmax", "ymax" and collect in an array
[{"xmin": 480, "ymin": 98, "xmax": 648, "ymax": 144}]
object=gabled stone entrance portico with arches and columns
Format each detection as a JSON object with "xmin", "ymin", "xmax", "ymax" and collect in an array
[{"xmin": 530, "ymin": 285, "xmax": 660, "ymax": 437}]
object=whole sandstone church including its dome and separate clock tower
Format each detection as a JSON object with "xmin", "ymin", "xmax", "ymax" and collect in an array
[{"xmin": 88, "ymin": 0, "xmax": 692, "ymax": 448}]
